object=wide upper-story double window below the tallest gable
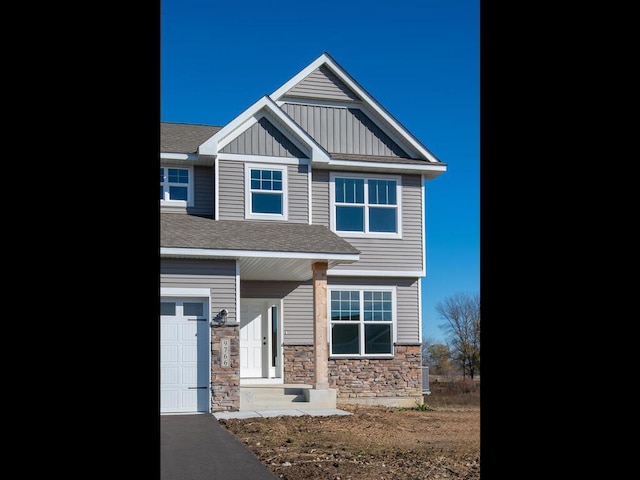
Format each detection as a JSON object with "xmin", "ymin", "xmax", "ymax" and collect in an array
[{"xmin": 330, "ymin": 173, "xmax": 402, "ymax": 238}]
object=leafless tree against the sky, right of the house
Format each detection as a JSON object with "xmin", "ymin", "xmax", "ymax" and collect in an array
[{"xmin": 435, "ymin": 293, "xmax": 480, "ymax": 379}]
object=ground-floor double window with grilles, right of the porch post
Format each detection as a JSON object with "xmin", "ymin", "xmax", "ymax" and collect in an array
[{"xmin": 329, "ymin": 287, "xmax": 395, "ymax": 357}]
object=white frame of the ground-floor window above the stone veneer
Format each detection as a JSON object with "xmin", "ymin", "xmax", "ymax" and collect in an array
[{"xmin": 327, "ymin": 285, "xmax": 398, "ymax": 358}]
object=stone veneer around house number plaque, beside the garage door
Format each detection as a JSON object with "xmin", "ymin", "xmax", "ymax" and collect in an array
[{"xmin": 211, "ymin": 325, "xmax": 240, "ymax": 412}]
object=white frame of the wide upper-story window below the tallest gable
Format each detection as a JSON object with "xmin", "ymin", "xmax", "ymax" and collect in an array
[{"xmin": 329, "ymin": 172, "xmax": 402, "ymax": 238}]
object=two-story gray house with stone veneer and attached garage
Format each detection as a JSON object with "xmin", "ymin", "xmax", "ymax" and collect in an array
[{"xmin": 160, "ymin": 53, "xmax": 446, "ymax": 413}]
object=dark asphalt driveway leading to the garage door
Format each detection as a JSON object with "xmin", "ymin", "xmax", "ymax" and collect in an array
[{"xmin": 160, "ymin": 414, "xmax": 277, "ymax": 480}]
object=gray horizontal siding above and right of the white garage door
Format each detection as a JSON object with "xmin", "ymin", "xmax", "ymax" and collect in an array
[{"xmin": 160, "ymin": 259, "xmax": 237, "ymax": 322}]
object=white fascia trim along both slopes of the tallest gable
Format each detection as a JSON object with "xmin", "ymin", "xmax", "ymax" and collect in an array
[{"xmin": 270, "ymin": 53, "xmax": 440, "ymax": 163}]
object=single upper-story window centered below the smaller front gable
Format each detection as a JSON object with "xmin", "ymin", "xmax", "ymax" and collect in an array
[{"xmin": 245, "ymin": 164, "xmax": 287, "ymax": 220}]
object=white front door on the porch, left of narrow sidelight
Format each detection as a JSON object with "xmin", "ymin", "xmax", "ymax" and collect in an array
[{"xmin": 240, "ymin": 300, "xmax": 266, "ymax": 378}]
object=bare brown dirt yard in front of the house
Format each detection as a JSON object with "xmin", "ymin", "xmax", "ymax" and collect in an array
[{"xmin": 221, "ymin": 383, "xmax": 480, "ymax": 480}]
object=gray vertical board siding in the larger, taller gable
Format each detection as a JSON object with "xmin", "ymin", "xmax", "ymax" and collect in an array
[{"xmin": 282, "ymin": 103, "xmax": 409, "ymax": 158}]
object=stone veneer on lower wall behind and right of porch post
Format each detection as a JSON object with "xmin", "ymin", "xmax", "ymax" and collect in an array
[{"xmin": 284, "ymin": 344, "xmax": 423, "ymax": 406}]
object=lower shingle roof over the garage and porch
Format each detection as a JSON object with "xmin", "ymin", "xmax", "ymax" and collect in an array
[{"xmin": 160, "ymin": 213, "xmax": 360, "ymax": 254}]
